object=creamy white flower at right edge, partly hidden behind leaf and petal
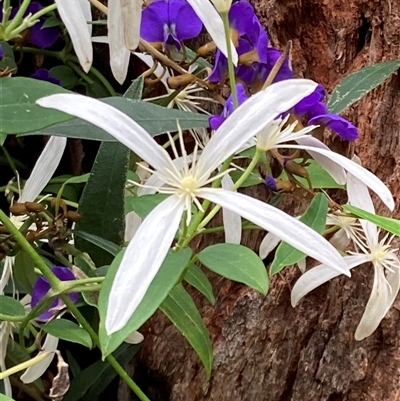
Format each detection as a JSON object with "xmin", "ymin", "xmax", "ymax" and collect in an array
[{"xmin": 292, "ymin": 158, "xmax": 400, "ymax": 341}]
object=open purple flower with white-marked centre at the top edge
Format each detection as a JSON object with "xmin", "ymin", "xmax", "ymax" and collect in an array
[{"xmin": 140, "ymin": 0, "xmax": 203, "ymax": 50}]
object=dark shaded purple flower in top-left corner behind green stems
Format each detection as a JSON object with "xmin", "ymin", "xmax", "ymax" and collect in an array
[{"xmin": 10, "ymin": 2, "xmax": 60, "ymax": 48}]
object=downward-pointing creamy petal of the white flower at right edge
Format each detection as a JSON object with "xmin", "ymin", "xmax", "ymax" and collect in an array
[{"xmin": 354, "ymin": 266, "xmax": 400, "ymax": 341}]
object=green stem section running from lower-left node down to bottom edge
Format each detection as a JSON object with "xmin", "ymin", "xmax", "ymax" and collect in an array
[{"xmin": 61, "ymin": 295, "xmax": 150, "ymax": 401}]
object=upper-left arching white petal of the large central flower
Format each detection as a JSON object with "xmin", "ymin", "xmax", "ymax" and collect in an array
[{"xmin": 36, "ymin": 94, "xmax": 170, "ymax": 170}]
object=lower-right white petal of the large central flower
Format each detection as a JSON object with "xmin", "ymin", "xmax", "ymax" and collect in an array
[{"xmin": 198, "ymin": 188, "xmax": 350, "ymax": 275}]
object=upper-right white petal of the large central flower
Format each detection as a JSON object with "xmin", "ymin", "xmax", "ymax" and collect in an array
[{"xmin": 197, "ymin": 78, "xmax": 317, "ymax": 176}]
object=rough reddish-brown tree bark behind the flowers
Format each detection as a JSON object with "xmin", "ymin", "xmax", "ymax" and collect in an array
[{"xmin": 124, "ymin": 0, "xmax": 400, "ymax": 401}]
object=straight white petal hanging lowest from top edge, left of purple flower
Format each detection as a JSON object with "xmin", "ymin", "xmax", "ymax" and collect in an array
[{"xmin": 107, "ymin": 0, "xmax": 131, "ymax": 85}]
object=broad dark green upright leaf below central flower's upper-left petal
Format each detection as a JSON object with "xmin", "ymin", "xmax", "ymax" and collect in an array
[{"xmin": 76, "ymin": 142, "xmax": 129, "ymax": 267}]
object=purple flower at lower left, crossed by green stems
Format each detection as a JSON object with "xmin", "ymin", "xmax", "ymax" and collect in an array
[{"xmin": 31, "ymin": 266, "xmax": 79, "ymax": 320}]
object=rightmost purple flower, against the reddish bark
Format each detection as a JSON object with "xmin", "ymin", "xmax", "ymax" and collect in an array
[{"xmin": 308, "ymin": 102, "xmax": 358, "ymax": 141}]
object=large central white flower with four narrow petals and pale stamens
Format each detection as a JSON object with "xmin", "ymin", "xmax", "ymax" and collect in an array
[{"xmin": 37, "ymin": 80, "xmax": 348, "ymax": 334}]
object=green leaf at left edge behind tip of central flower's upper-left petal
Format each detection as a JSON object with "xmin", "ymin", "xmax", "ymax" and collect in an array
[{"xmin": 0, "ymin": 77, "xmax": 71, "ymax": 134}]
